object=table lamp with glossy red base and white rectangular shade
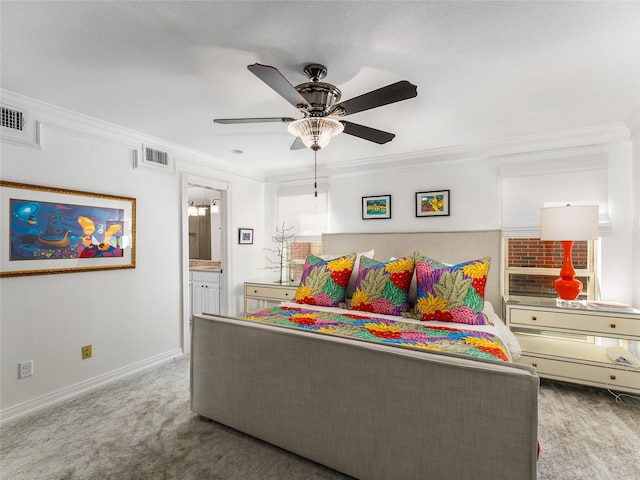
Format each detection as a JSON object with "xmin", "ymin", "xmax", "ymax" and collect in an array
[{"xmin": 540, "ymin": 205, "xmax": 598, "ymax": 307}]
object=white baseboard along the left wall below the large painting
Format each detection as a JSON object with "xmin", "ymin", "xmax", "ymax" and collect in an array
[{"xmin": 0, "ymin": 348, "xmax": 184, "ymax": 425}]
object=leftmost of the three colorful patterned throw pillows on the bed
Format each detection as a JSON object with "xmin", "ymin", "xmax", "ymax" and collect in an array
[{"xmin": 296, "ymin": 253, "xmax": 356, "ymax": 307}]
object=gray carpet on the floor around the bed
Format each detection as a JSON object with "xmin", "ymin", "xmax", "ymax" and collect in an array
[{"xmin": 0, "ymin": 359, "xmax": 640, "ymax": 480}]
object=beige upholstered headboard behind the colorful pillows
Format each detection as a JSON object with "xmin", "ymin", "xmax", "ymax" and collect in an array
[{"xmin": 322, "ymin": 230, "xmax": 502, "ymax": 316}]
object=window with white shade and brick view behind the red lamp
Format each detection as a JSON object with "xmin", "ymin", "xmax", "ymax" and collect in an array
[{"xmin": 500, "ymin": 153, "xmax": 610, "ymax": 299}]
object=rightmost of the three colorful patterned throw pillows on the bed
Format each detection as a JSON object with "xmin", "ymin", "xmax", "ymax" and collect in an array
[{"xmin": 415, "ymin": 252, "xmax": 491, "ymax": 325}]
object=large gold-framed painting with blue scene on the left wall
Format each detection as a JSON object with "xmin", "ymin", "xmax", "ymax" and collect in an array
[{"xmin": 0, "ymin": 180, "xmax": 136, "ymax": 277}]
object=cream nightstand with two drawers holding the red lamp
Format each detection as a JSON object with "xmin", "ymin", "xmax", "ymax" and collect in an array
[{"xmin": 503, "ymin": 297, "xmax": 640, "ymax": 394}]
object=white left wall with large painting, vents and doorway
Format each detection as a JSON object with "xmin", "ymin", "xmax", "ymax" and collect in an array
[{"xmin": 0, "ymin": 92, "xmax": 264, "ymax": 419}]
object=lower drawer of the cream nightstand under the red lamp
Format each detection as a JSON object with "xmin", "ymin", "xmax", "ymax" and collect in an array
[{"xmin": 517, "ymin": 355, "xmax": 640, "ymax": 393}]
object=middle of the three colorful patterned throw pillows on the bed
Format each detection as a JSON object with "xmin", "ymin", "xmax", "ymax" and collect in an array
[{"xmin": 351, "ymin": 256, "xmax": 414, "ymax": 316}]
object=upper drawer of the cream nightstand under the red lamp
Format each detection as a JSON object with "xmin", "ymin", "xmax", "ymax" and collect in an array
[{"xmin": 509, "ymin": 308, "xmax": 640, "ymax": 338}]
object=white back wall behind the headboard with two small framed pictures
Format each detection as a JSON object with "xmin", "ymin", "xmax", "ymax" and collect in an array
[{"xmin": 267, "ymin": 126, "xmax": 640, "ymax": 307}]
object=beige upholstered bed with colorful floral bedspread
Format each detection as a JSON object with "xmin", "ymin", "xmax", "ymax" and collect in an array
[{"xmin": 191, "ymin": 231, "xmax": 539, "ymax": 480}]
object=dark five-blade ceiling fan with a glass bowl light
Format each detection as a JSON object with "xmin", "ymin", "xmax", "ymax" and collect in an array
[{"xmin": 213, "ymin": 63, "xmax": 418, "ymax": 151}]
